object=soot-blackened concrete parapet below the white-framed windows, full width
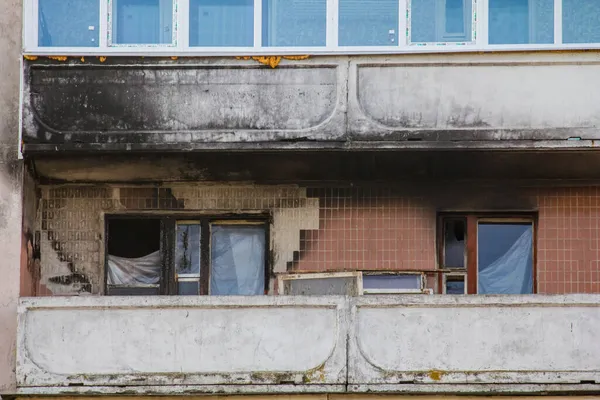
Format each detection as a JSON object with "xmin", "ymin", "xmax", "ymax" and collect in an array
[{"xmin": 24, "ymin": 52, "xmax": 600, "ymax": 151}]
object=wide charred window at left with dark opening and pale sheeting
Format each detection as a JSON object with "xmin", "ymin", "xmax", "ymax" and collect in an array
[{"xmin": 106, "ymin": 217, "xmax": 268, "ymax": 295}]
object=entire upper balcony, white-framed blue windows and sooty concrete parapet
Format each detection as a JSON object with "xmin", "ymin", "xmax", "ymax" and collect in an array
[{"xmin": 22, "ymin": 0, "xmax": 600, "ymax": 154}]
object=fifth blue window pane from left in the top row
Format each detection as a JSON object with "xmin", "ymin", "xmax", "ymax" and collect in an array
[{"xmin": 338, "ymin": 0, "xmax": 398, "ymax": 46}]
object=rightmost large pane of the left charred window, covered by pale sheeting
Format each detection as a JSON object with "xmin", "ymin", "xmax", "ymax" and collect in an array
[{"xmin": 210, "ymin": 225, "xmax": 265, "ymax": 296}]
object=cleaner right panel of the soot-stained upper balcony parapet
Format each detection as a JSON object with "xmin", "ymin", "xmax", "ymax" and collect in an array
[{"xmin": 348, "ymin": 57, "xmax": 600, "ymax": 141}]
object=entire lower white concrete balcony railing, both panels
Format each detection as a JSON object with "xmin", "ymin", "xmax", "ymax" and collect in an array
[{"xmin": 17, "ymin": 295, "xmax": 600, "ymax": 394}]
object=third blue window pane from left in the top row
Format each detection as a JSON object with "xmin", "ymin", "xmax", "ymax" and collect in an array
[{"xmin": 190, "ymin": 0, "xmax": 254, "ymax": 47}]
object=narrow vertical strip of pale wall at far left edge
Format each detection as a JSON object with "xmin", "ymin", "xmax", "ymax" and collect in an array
[{"xmin": 0, "ymin": 0, "xmax": 22, "ymax": 394}]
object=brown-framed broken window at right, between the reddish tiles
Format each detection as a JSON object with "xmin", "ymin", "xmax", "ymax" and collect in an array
[{"xmin": 439, "ymin": 215, "xmax": 534, "ymax": 294}]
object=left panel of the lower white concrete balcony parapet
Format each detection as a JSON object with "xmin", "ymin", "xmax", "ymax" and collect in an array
[{"xmin": 17, "ymin": 297, "xmax": 347, "ymax": 390}]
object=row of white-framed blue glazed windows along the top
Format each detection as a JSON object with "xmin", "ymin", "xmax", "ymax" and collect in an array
[{"xmin": 24, "ymin": 0, "xmax": 600, "ymax": 55}]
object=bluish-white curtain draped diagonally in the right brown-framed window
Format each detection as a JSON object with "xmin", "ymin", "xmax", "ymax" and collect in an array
[{"xmin": 477, "ymin": 229, "xmax": 533, "ymax": 294}]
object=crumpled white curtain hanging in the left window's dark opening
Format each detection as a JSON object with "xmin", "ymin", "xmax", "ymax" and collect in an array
[{"xmin": 107, "ymin": 251, "xmax": 161, "ymax": 286}]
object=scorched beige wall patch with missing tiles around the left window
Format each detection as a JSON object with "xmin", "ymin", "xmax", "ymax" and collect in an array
[{"xmin": 38, "ymin": 184, "xmax": 319, "ymax": 295}]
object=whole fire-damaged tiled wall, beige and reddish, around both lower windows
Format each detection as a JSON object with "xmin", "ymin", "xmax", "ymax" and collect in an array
[{"xmin": 31, "ymin": 183, "xmax": 600, "ymax": 295}]
